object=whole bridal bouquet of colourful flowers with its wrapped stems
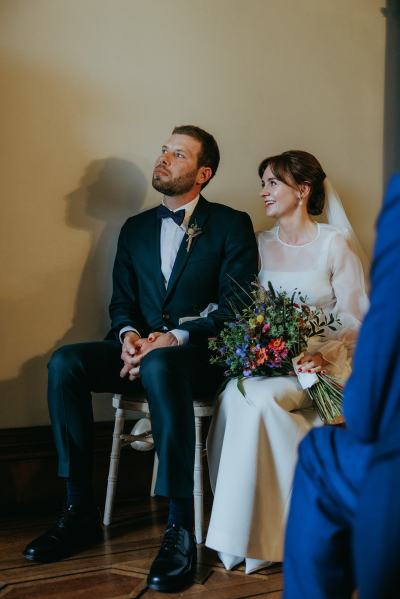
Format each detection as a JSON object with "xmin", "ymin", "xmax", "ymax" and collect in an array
[{"xmin": 209, "ymin": 283, "xmax": 343, "ymax": 424}]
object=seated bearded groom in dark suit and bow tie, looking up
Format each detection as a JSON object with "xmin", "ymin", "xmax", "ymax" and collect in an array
[{"xmin": 24, "ymin": 125, "xmax": 257, "ymax": 591}]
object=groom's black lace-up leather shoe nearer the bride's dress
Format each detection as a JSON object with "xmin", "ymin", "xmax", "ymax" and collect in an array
[{"xmin": 147, "ymin": 524, "xmax": 196, "ymax": 593}]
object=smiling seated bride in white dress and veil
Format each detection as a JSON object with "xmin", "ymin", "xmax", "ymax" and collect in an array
[{"xmin": 206, "ymin": 151, "xmax": 367, "ymax": 573}]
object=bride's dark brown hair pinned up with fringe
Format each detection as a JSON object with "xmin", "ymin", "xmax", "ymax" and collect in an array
[{"xmin": 258, "ymin": 150, "xmax": 326, "ymax": 216}]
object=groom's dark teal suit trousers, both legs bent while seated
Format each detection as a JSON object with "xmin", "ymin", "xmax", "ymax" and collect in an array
[{"xmin": 48, "ymin": 340, "xmax": 222, "ymax": 497}]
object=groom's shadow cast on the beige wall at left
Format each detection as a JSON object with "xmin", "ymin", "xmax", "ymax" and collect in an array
[{"xmin": 0, "ymin": 158, "xmax": 147, "ymax": 424}]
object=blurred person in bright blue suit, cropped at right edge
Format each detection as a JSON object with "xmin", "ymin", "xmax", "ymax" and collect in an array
[{"xmin": 284, "ymin": 174, "xmax": 400, "ymax": 599}]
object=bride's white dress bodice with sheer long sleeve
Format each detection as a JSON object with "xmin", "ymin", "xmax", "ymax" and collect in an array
[{"xmin": 257, "ymin": 223, "xmax": 368, "ymax": 379}]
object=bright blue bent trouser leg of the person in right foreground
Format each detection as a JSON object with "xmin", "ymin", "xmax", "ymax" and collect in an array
[{"xmin": 284, "ymin": 426, "xmax": 372, "ymax": 599}]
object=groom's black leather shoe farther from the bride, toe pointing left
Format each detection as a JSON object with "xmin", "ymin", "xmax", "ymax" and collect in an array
[{"xmin": 22, "ymin": 505, "xmax": 102, "ymax": 562}]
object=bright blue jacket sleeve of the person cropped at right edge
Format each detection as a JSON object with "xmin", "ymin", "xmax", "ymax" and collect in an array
[{"xmin": 345, "ymin": 175, "xmax": 400, "ymax": 442}]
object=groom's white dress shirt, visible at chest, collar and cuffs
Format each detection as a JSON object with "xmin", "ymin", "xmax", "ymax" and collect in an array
[{"xmin": 119, "ymin": 195, "xmax": 200, "ymax": 345}]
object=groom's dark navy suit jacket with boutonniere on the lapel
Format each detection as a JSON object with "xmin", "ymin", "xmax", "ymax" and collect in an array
[{"xmin": 106, "ymin": 196, "xmax": 258, "ymax": 344}]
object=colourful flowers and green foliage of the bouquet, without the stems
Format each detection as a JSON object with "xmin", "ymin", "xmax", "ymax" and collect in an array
[{"xmin": 209, "ymin": 282, "xmax": 340, "ymax": 377}]
